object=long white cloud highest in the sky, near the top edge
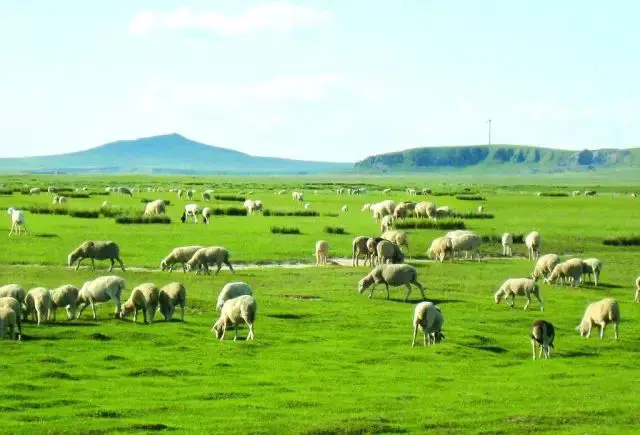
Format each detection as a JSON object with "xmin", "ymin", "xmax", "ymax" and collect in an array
[{"xmin": 129, "ymin": 3, "xmax": 331, "ymax": 36}]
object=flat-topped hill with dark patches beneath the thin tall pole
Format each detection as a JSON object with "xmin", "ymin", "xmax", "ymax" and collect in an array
[{"xmin": 355, "ymin": 145, "xmax": 640, "ymax": 173}]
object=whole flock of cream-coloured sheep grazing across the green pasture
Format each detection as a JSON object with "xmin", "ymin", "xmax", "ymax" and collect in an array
[{"xmin": 5, "ymin": 188, "xmax": 640, "ymax": 359}]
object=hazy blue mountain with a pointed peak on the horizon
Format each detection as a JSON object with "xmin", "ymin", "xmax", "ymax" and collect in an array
[{"xmin": 0, "ymin": 134, "xmax": 353, "ymax": 174}]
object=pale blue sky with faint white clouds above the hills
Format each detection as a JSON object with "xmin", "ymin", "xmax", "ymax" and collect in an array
[{"xmin": 0, "ymin": 0, "xmax": 640, "ymax": 162}]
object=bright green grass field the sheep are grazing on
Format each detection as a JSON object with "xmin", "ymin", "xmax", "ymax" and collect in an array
[{"xmin": 0, "ymin": 176, "xmax": 640, "ymax": 434}]
